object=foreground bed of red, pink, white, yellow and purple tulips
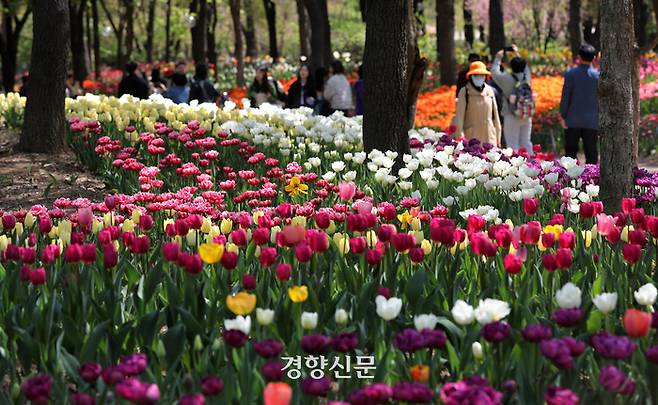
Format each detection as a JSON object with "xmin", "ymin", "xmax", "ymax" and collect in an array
[{"xmin": 0, "ymin": 94, "xmax": 658, "ymax": 405}]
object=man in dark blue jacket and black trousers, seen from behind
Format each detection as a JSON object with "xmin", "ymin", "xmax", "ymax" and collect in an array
[{"xmin": 560, "ymin": 44, "xmax": 599, "ymax": 165}]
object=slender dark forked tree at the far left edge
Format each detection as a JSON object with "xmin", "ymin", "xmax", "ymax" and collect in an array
[{"xmin": 0, "ymin": 0, "xmax": 32, "ymax": 93}]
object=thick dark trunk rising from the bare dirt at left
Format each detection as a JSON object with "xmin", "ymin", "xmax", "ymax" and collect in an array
[{"xmin": 18, "ymin": 0, "xmax": 70, "ymax": 153}]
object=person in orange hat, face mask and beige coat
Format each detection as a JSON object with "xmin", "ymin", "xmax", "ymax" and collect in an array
[{"xmin": 455, "ymin": 61, "xmax": 501, "ymax": 146}]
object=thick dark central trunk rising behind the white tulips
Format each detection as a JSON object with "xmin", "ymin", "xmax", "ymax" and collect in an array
[{"xmin": 363, "ymin": 0, "xmax": 427, "ymax": 162}]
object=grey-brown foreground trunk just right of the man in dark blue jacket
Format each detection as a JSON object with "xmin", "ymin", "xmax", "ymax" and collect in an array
[{"xmin": 599, "ymin": 0, "xmax": 635, "ymax": 213}]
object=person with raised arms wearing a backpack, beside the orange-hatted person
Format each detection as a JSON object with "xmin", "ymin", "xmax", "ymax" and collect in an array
[{"xmin": 491, "ymin": 45, "xmax": 534, "ymax": 155}]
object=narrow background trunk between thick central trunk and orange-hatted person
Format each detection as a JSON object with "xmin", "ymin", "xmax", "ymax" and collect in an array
[{"xmin": 436, "ymin": 0, "xmax": 457, "ymax": 86}]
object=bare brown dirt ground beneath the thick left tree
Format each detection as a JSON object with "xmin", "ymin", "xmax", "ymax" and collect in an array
[{"xmin": 0, "ymin": 129, "xmax": 105, "ymax": 211}]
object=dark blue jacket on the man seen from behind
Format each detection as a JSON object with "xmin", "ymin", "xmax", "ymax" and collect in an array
[{"xmin": 560, "ymin": 64, "xmax": 599, "ymax": 129}]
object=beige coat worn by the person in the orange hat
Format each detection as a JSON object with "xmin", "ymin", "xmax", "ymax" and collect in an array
[{"xmin": 455, "ymin": 82, "xmax": 502, "ymax": 146}]
